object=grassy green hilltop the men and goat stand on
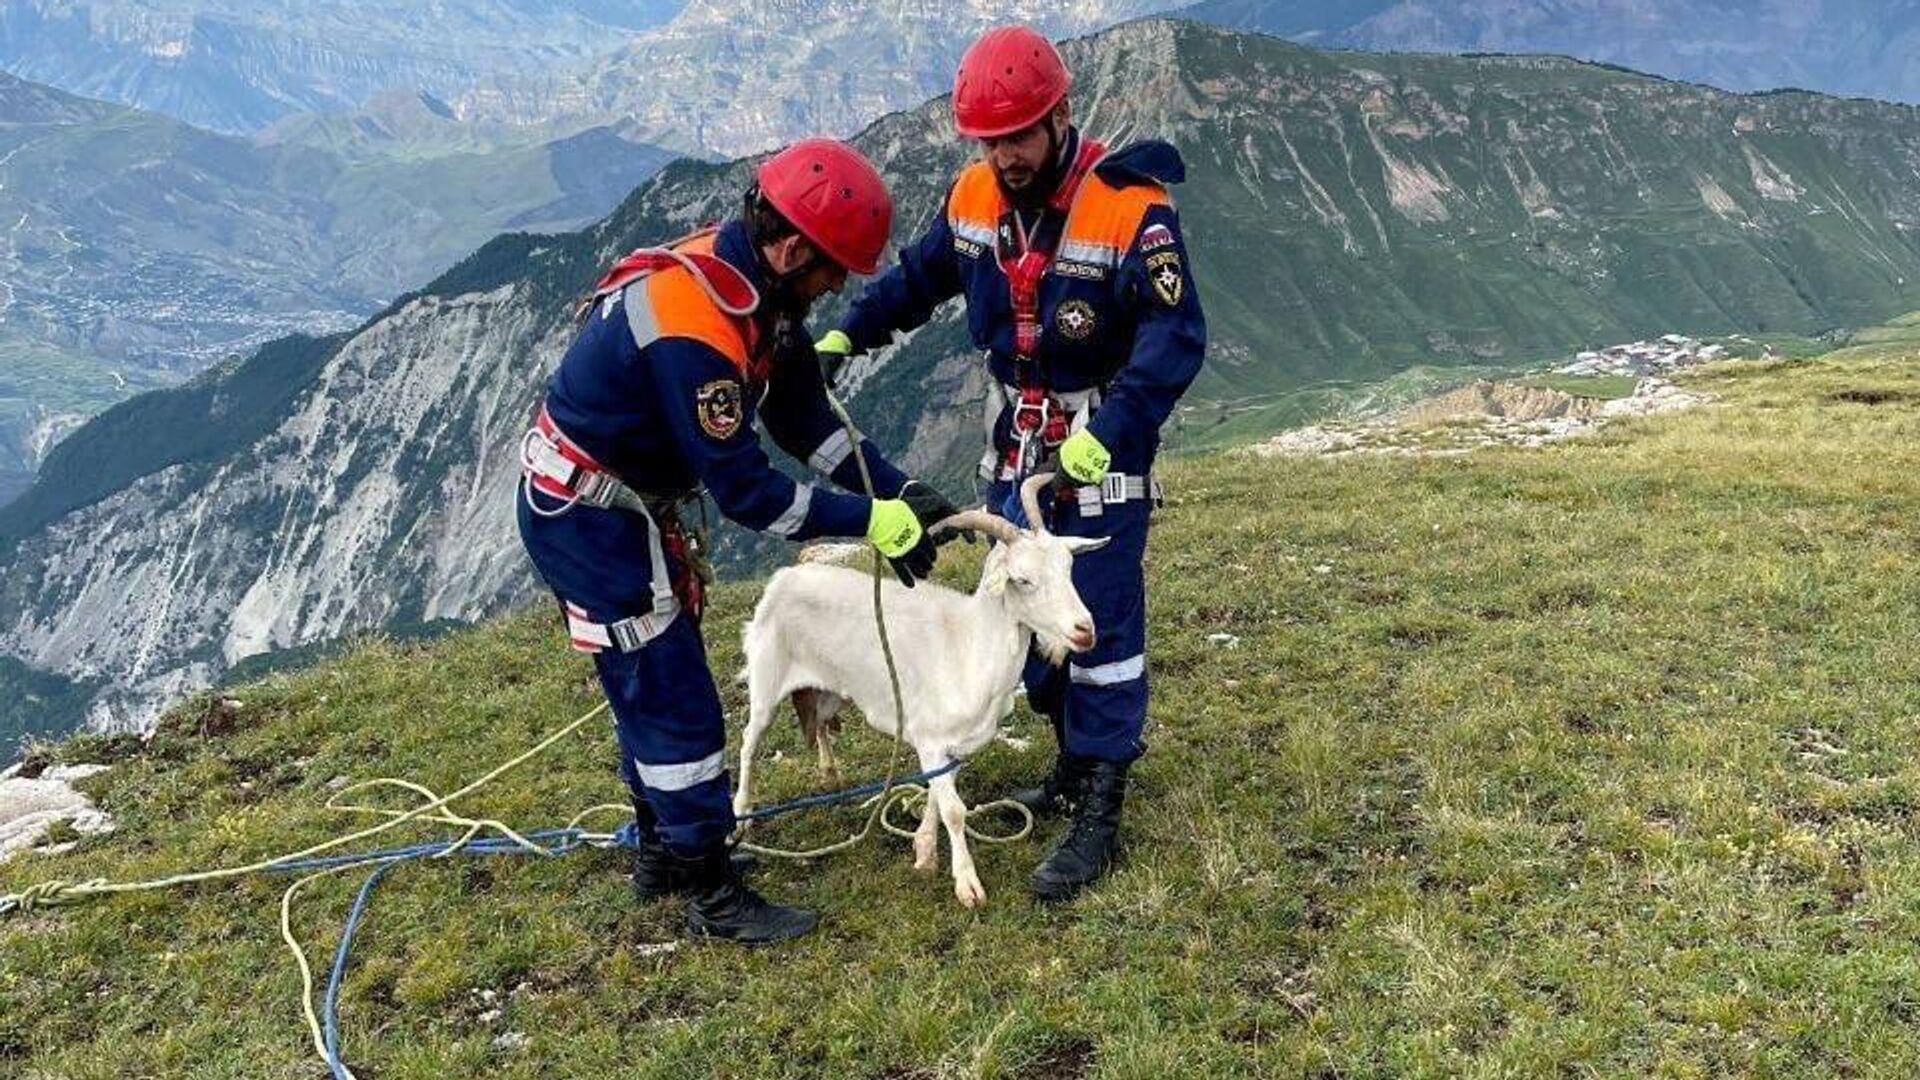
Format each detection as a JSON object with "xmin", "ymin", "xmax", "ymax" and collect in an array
[{"xmin": 0, "ymin": 321, "xmax": 1920, "ymax": 1080}]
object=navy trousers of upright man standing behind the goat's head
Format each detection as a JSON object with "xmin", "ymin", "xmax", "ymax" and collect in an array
[{"xmin": 987, "ymin": 474, "xmax": 1152, "ymax": 761}]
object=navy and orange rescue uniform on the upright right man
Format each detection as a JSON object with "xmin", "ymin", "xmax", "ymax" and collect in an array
[{"xmin": 841, "ymin": 133, "xmax": 1206, "ymax": 761}]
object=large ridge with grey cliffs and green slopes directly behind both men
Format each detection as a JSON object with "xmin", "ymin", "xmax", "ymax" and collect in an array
[{"xmin": 0, "ymin": 21, "xmax": 1920, "ymax": 724}]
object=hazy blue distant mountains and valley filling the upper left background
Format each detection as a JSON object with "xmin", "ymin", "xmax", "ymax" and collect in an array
[{"xmin": 0, "ymin": 0, "xmax": 1169, "ymax": 505}]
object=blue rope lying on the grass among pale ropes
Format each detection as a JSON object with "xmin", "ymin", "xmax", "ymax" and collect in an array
[{"xmin": 307, "ymin": 761, "xmax": 962, "ymax": 1080}]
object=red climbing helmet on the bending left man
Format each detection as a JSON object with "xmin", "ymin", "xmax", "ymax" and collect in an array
[{"xmin": 756, "ymin": 138, "xmax": 893, "ymax": 273}]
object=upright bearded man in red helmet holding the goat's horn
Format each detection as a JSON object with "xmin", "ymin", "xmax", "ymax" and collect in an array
[{"xmin": 816, "ymin": 27, "xmax": 1206, "ymax": 899}]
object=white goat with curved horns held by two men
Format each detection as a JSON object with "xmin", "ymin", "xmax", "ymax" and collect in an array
[{"xmin": 733, "ymin": 475, "xmax": 1106, "ymax": 907}]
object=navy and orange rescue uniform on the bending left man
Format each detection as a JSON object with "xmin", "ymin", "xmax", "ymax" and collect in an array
[{"xmin": 518, "ymin": 221, "xmax": 906, "ymax": 853}]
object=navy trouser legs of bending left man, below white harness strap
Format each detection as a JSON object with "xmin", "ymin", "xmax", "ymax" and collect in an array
[{"xmin": 593, "ymin": 613, "xmax": 733, "ymax": 855}]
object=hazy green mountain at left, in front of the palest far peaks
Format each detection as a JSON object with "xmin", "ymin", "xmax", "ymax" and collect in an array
[{"xmin": 0, "ymin": 73, "xmax": 668, "ymax": 502}]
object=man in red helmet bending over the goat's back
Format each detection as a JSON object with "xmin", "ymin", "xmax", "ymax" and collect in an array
[{"xmin": 518, "ymin": 138, "xmax": 954, "ymax": 942}]
